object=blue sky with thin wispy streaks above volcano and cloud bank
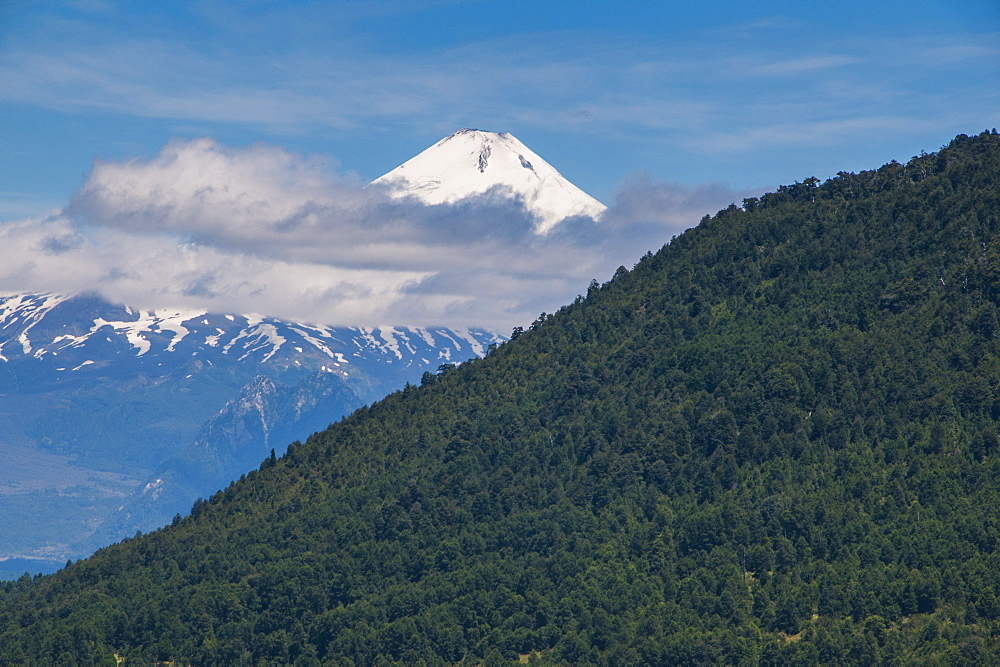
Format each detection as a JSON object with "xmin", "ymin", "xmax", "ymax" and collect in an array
[{"xmin": 0, "ymin": 0, "xmax": 1000, "ymax": 322}]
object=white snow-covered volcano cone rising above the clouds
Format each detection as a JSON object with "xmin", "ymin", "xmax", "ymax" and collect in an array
[{"xmin": 372, "ymin": 128, "xmax": 606, "ymax": 234}]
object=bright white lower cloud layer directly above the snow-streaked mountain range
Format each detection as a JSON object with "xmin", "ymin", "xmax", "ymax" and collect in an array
[{"xmin": 0, "ymin": 211, "xmax": 425, "ymax": 324}]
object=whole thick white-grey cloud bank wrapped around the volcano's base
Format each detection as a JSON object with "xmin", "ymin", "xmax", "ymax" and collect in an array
[{"xmin": 0, "ymin": 139, "xmax": 749, "ymax": 330}]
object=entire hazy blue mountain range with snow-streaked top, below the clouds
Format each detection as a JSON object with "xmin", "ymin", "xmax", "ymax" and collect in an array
[{"xmin": 0, "ymin": 294, "xmax": 505, "ymax": 571}]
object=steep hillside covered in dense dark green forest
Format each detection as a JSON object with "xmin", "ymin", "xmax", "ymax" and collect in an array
[{"xmin": 0, "ymin": 131, "xmax": 1000, "ymax": 665}]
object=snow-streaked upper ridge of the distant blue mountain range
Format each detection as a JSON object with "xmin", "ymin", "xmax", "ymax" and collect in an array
[{"xmin": 0, "ymin": 294, "xmax": 505, "ymax": 374}]
